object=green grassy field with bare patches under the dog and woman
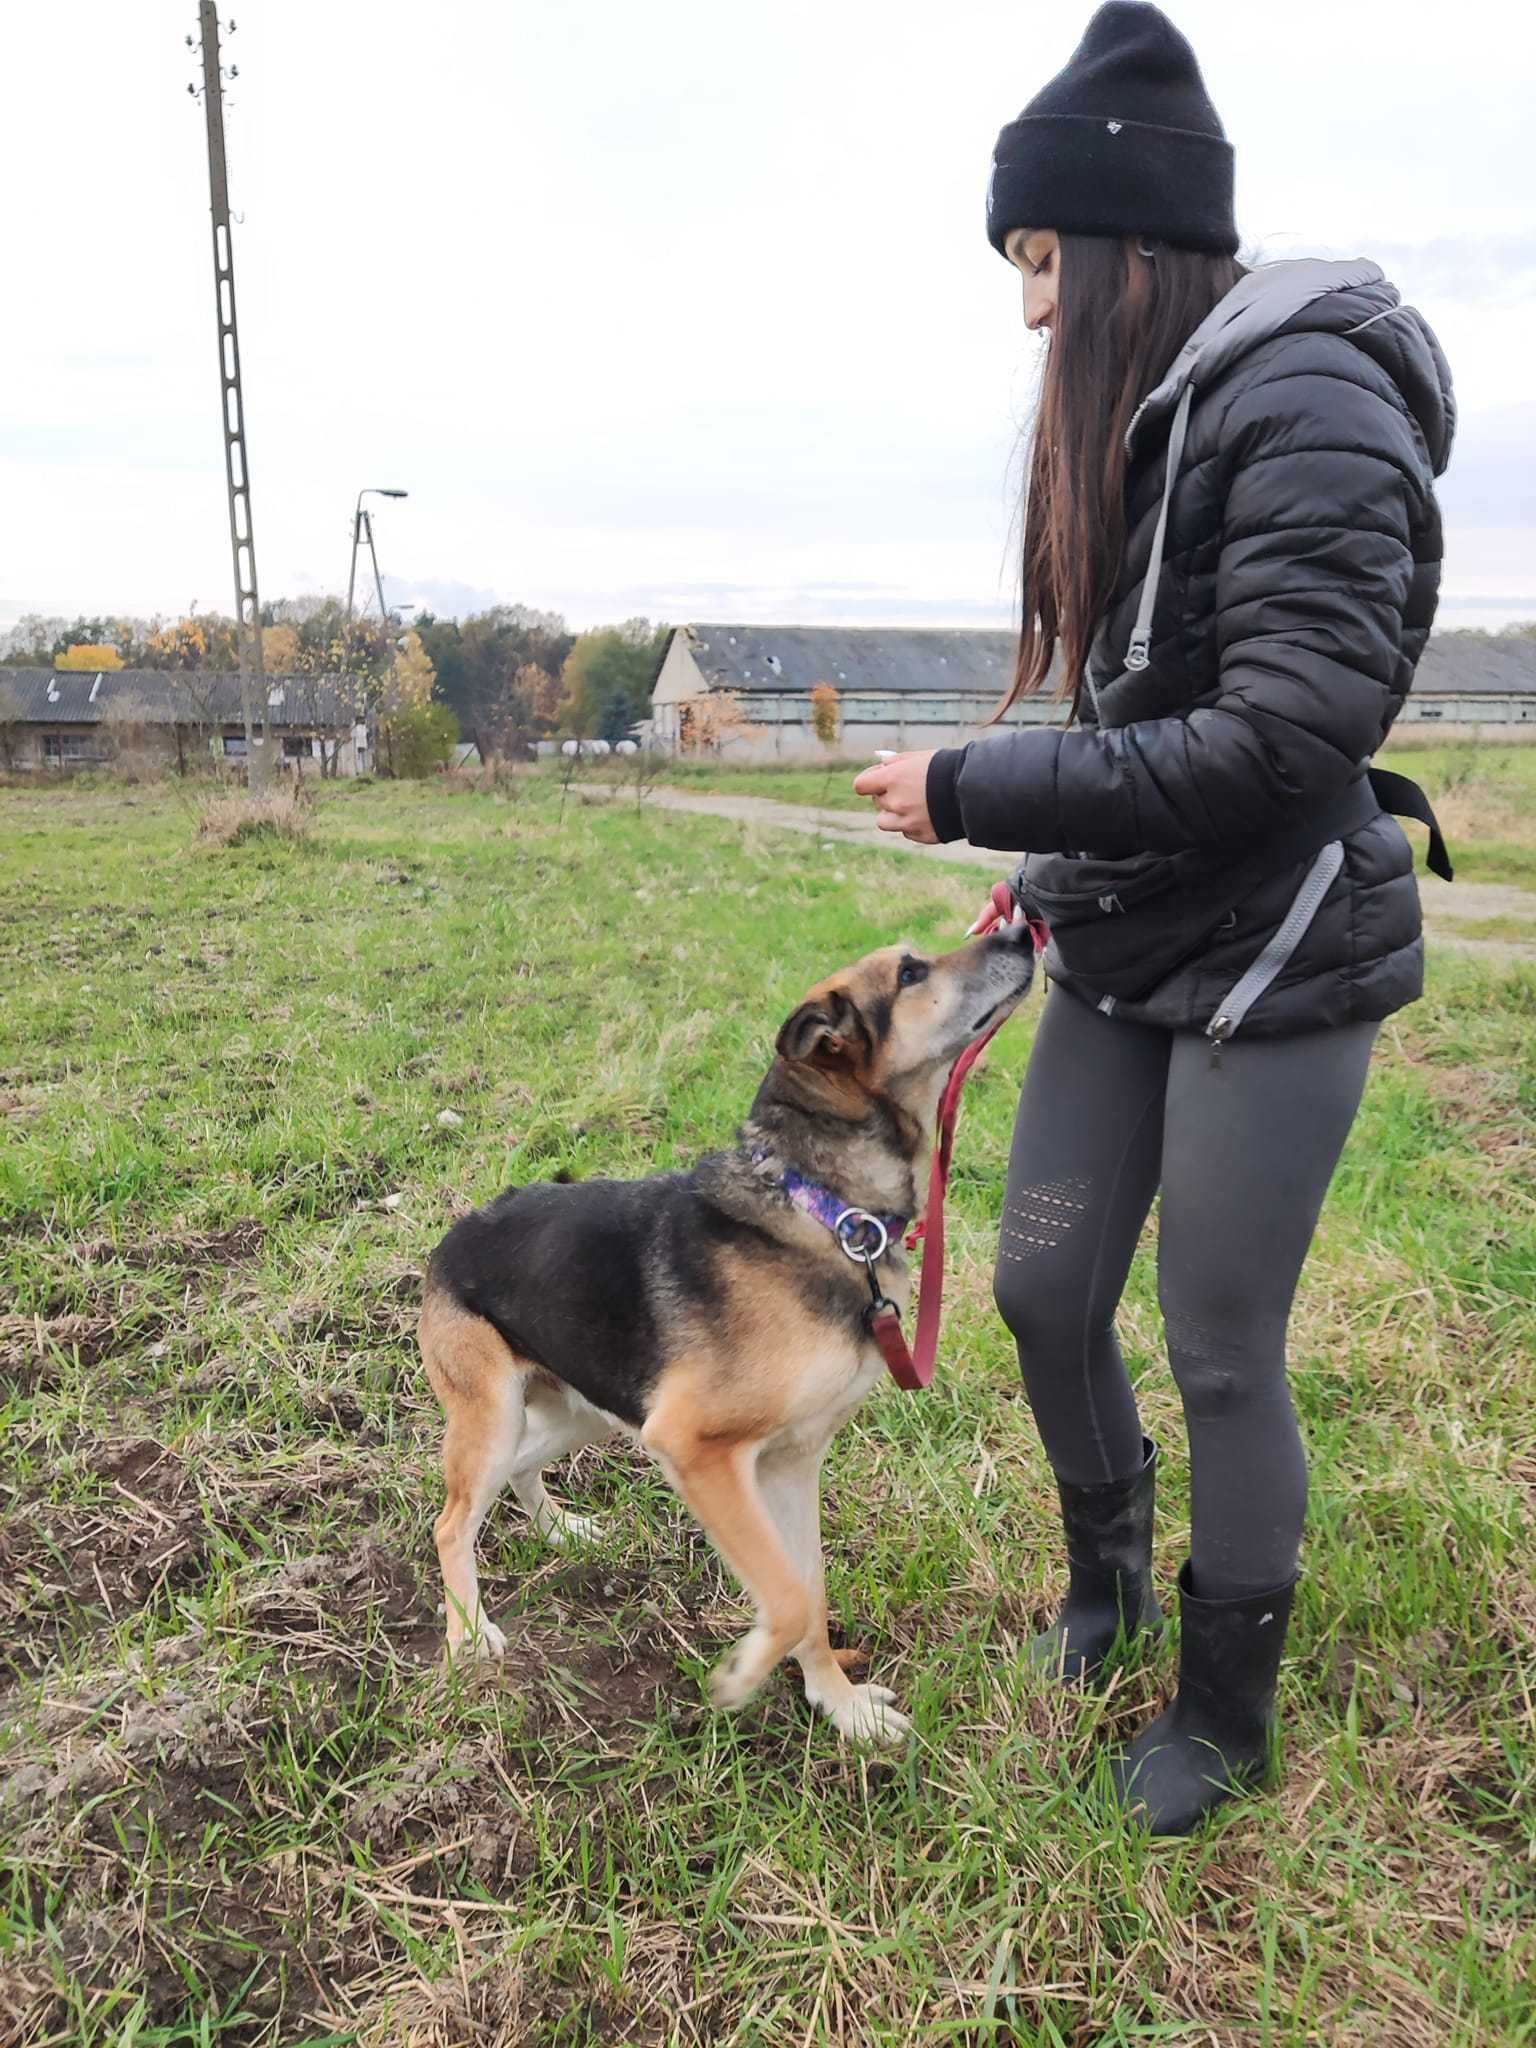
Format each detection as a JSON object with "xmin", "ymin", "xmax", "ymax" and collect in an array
[{"xmin": 0, "ymin": 760, "xmax": 1536, "ymax": 2048}]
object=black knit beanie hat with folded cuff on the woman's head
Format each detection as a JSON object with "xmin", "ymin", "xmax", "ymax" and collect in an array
[{"xmin": 987, "ymin": 0, "xmax": 1237, "ymax": 256}]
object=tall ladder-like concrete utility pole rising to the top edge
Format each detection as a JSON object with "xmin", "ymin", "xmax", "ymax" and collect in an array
[{"xmin": 196, "ymin": 0, "xmax": 272, "ymax": 793}]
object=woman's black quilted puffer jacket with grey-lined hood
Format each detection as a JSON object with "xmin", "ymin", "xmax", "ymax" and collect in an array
[{"xmin": 928, "ymin": 260, "xmax": 1454, "ymax": 1034}]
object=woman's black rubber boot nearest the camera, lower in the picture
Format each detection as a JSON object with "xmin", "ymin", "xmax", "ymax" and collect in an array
[{"xmin": 1110, "ymin": 1563, "xmax": 1296, "ymax": 1835}]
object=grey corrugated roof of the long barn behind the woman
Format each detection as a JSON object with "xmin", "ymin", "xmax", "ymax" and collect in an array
[{"xmin": 676, "ymin": 623, "xmax": 1536, "ymax": 696}]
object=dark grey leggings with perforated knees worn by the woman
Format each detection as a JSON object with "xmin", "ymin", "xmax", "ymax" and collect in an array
[{"xmin": 995, "ymin": 987, "xmax": 1376, "ymax": 1599}]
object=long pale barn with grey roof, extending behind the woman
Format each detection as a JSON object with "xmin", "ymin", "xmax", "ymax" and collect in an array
[{"xmin": 651, "ymin": 625, "xmax": 1536, "ymax": 760}]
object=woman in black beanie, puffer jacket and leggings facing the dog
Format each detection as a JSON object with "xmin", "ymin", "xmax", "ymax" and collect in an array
[{"xmin": 854, "ymin": 0, "xmax": 1454, "ymax": 1833}]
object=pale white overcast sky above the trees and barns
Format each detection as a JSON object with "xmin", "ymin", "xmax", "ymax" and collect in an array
[{"xmin": 0, "ymin": 0, "xmax": 1536, "ymax": 629}]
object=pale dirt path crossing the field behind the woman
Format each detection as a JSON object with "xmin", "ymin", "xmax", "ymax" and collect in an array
[{"xmin": 614, "ymin": 788, "xmax": 1536, "ymax": 961}]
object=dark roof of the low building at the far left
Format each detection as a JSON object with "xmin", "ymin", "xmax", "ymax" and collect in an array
[{"xmin": 0, "ymin": 668, "xmax": 358, "ymax": 731}]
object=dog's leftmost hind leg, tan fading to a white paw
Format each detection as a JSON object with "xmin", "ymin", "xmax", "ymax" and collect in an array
[{"xmin": 420, "ymin": 1294, "xmax": 526, "ymax": 1657}]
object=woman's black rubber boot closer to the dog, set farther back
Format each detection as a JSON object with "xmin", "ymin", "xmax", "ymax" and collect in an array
[{"xmin": 1028, "ymin": 1438, "xmax": 1163, "ymax": 1683}]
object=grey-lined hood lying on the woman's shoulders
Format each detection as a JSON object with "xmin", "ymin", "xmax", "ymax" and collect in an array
[{"xmin": 1126, "ymin": 256, "xmax": 1456, "ymax": 475}]
